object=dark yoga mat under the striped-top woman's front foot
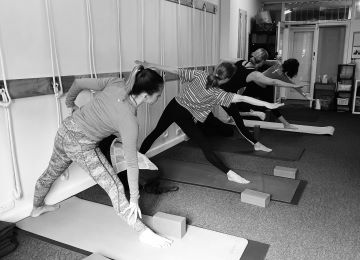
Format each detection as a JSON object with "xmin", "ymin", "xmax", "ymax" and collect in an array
[{"xmin": 153, "ymin": 157, "xmax": 301, "ymax": 204}]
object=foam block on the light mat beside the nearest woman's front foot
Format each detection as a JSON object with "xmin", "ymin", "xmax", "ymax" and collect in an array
[{"xmin": 153, "ymin": 212, "xmax": 186, "ymax": 238}]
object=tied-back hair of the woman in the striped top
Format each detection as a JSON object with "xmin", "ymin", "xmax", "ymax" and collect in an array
[{"xmin": 206, "ymin": 61, "xmax": 236, "ymax": 89}]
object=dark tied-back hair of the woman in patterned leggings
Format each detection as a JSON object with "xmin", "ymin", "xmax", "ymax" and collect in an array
[{"xmin": 125, "ymin": 65, "xmax": 164, "ymax": 95}]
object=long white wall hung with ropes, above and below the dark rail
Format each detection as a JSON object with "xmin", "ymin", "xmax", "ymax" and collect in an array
[{"xmin": 0, "ymin": 0, "xmax": 219, "ymax": 221}]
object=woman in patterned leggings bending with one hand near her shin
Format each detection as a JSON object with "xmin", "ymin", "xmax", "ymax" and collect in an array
[{"xmin": 31, "ymin": 66, "xmax": 172, "ymax": 247}]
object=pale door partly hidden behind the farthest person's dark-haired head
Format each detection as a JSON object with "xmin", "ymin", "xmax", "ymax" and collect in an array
[{"xmin": 285, "ymin": 25, "xmax": 318, "ymax": 99}]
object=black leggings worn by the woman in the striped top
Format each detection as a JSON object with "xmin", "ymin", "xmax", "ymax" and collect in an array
[{"xmin": 140, "ymin": 98, "xmax": 230, "ymax": 173}]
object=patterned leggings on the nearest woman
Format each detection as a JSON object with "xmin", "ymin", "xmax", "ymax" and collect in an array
[{"xmin": 34, "ymin": 116, "xmax": 146, "ymax": 232}]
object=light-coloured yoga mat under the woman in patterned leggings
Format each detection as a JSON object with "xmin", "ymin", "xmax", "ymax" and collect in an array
[{"xmin": 17, "ymin": 197, "xmax": 253, "ymax": 260}]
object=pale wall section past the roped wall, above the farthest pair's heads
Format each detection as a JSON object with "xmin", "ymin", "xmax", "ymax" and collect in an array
[{"xmin": 220, "ymin": 0, "xmax": 260, "ymax": 59}]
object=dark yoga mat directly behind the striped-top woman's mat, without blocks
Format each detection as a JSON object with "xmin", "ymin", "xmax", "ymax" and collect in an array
[{"xmin": 183, "ymin": 136, "xmax": 305, "ymax": 161}]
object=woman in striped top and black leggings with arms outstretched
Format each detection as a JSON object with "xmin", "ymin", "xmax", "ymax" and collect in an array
[{"xmin": 136, "ymin": 61, "xmax": 283, "ymax": 184}]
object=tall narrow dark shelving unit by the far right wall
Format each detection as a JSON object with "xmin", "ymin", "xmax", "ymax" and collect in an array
[{"xmin": 336, "ymin": 64, "xmax": 355, "ymax": 112}]
